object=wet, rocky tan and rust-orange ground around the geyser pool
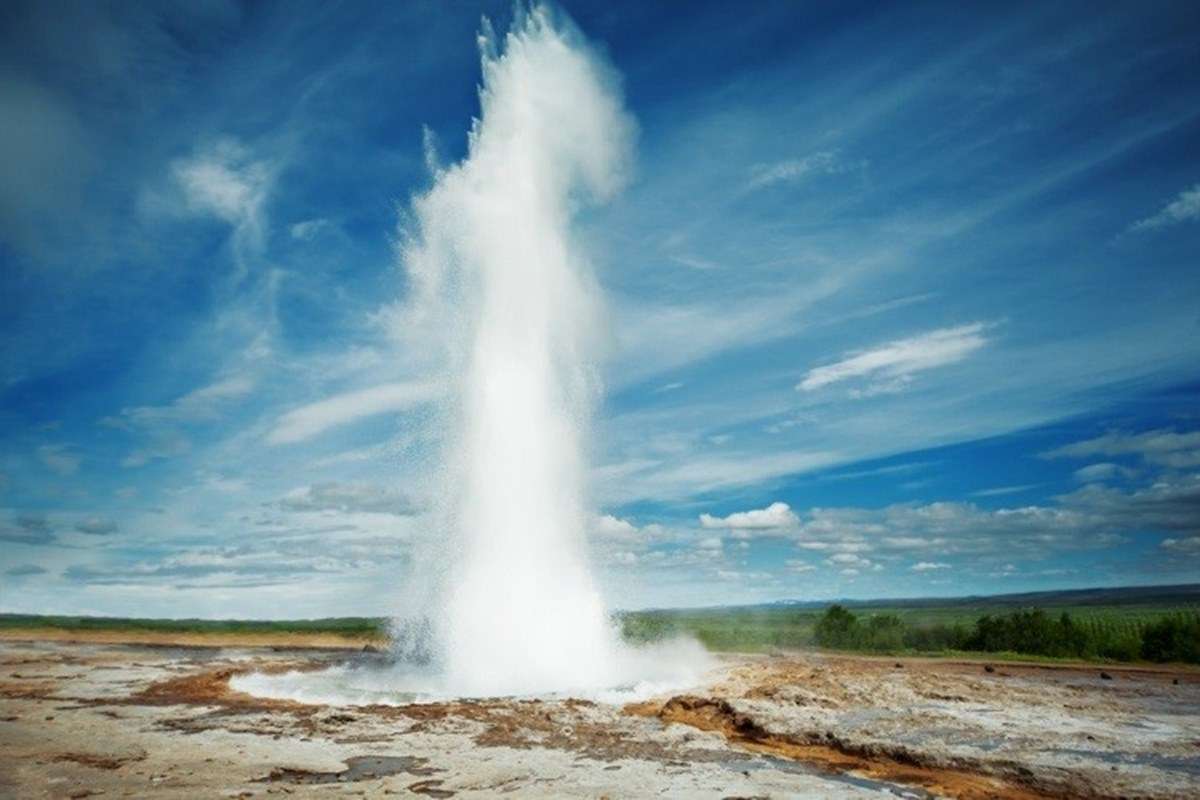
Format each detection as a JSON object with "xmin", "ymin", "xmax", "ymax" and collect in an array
[{"xmin": 0, "ymin": 638, "xmax": 1200, "ymax": 798}]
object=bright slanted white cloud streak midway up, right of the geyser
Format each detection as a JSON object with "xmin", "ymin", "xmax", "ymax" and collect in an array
[{"xmin": 796, "ymin": 323, "xmax": 988, "ymax": 397}]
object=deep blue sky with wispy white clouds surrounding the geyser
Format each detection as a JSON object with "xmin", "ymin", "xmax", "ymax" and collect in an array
[{"xmin": 0, "ymin": 2, "xmax": 1200, "ymax": 616}]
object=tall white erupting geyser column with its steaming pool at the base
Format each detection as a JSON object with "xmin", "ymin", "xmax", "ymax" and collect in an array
[{"xmin": 229, "ymin": 6, "xmax": 707, "ymax": 702}]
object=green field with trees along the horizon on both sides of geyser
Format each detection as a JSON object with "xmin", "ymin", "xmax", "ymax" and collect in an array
[{"xmin": 0, "ymin": 585, "xmax": 1200, "ymax": 662}]
